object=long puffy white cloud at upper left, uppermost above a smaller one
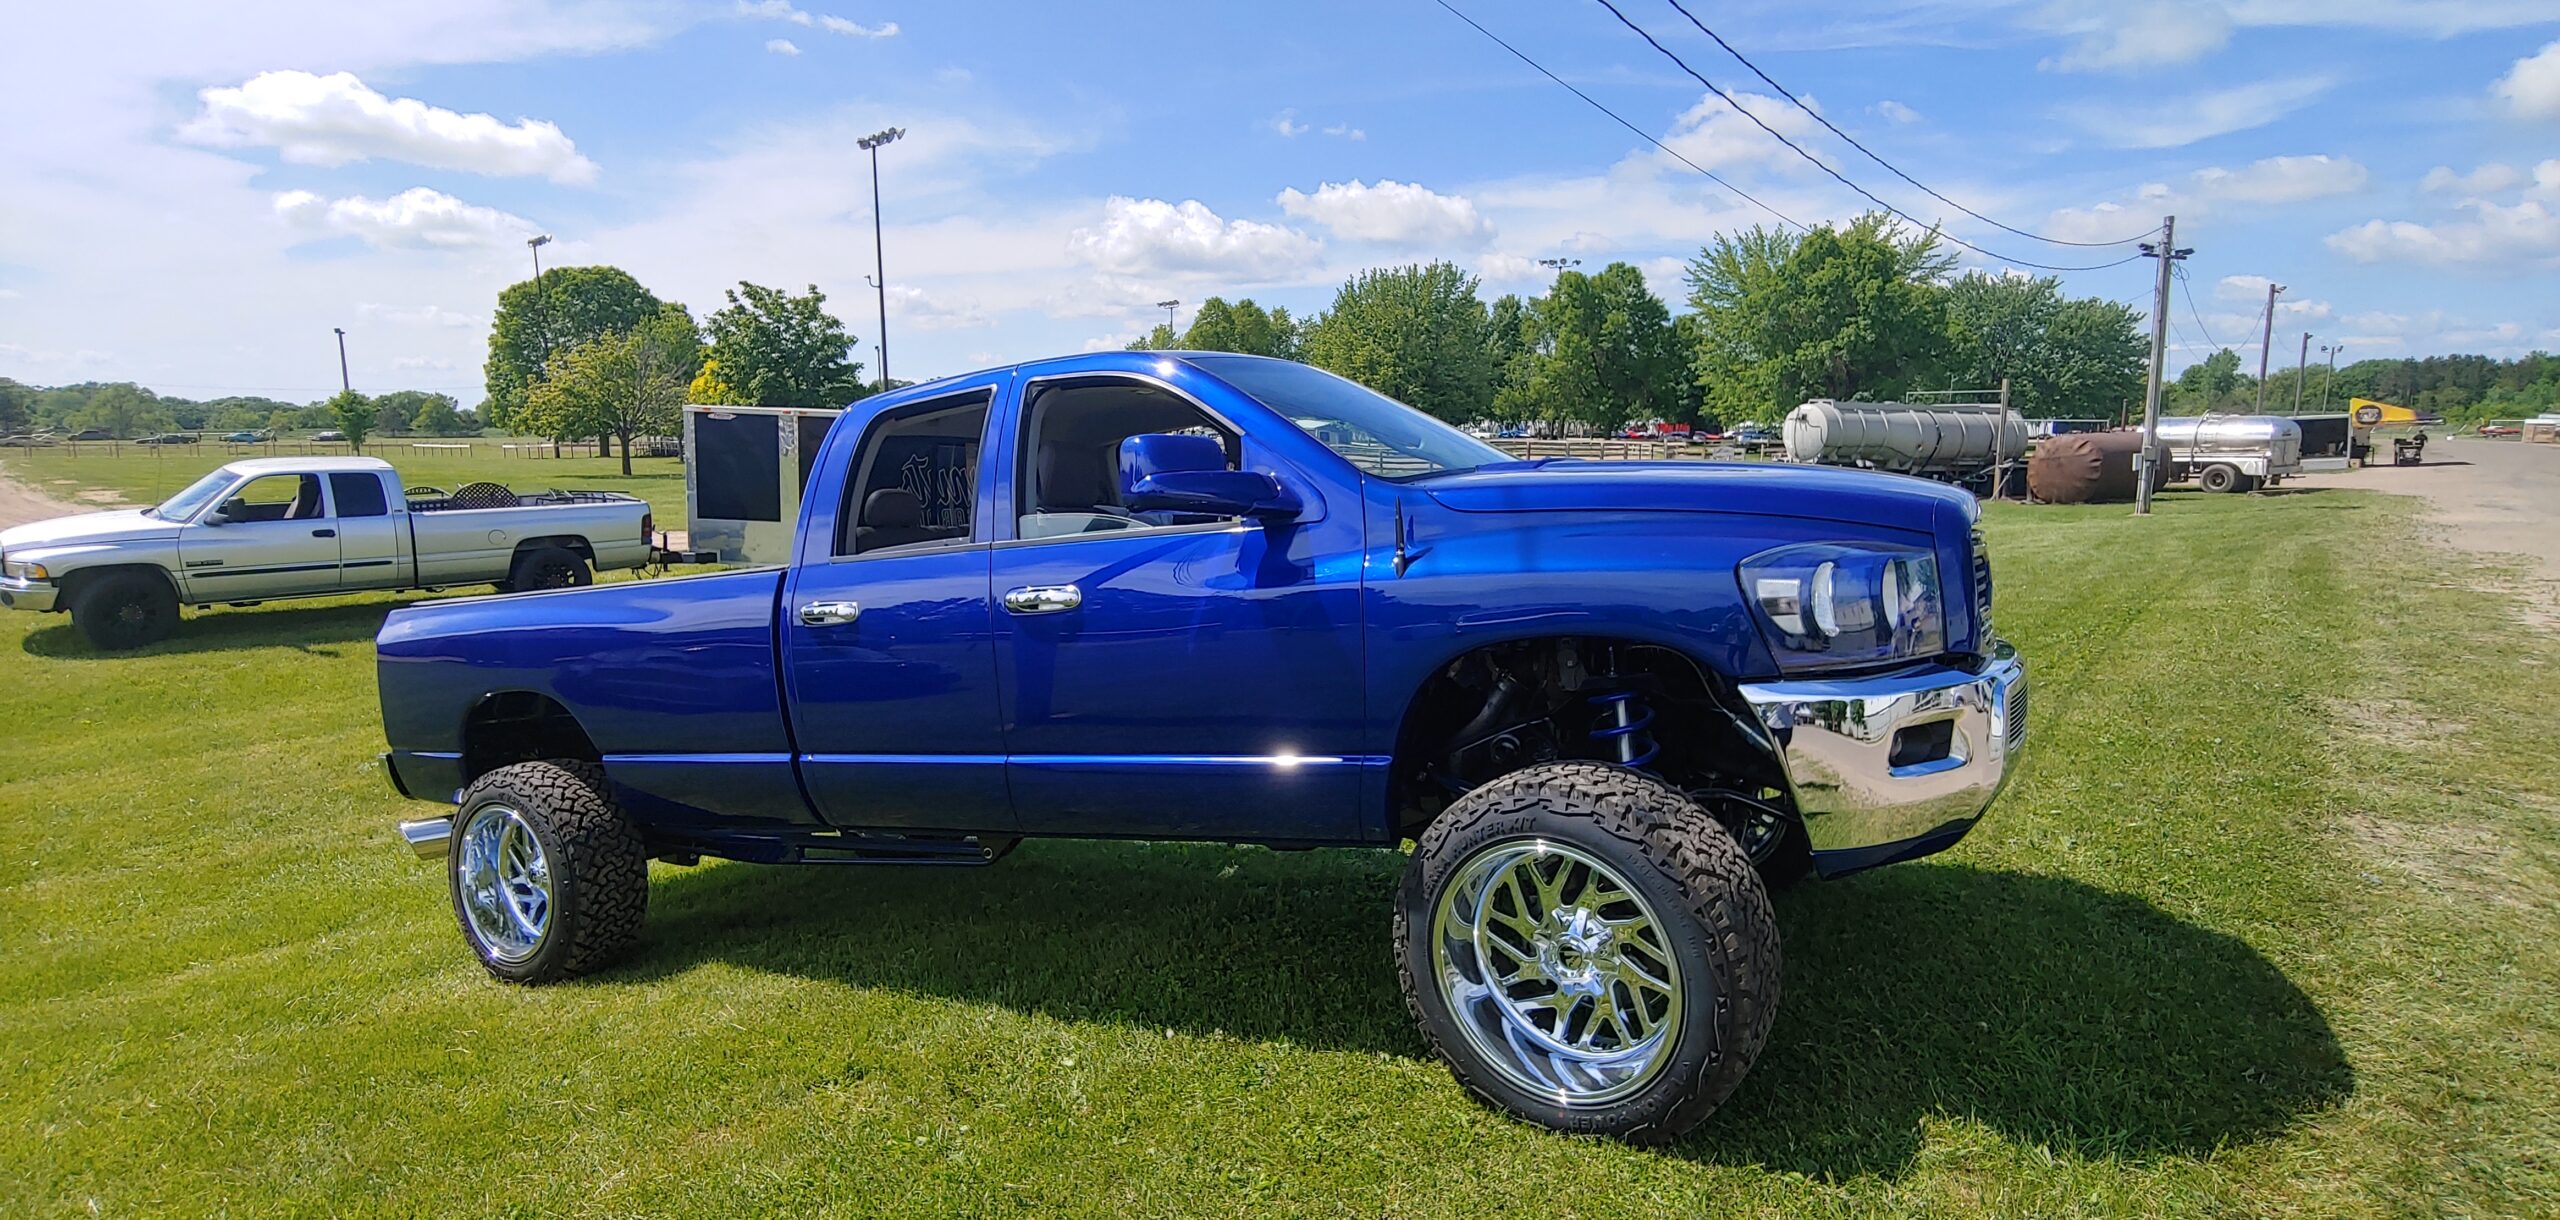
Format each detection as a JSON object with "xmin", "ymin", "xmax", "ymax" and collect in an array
[{"xmin": 179, "ymin": 72, "xmax": 596, "ymax": 182}]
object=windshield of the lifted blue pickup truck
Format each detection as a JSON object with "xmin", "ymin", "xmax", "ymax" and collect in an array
[{"xmin": 1185, "ymin": 356, "xmax": 1510, "ymax": 481}]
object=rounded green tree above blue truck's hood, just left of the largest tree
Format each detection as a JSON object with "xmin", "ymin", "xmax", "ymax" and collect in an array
[{"xmin": 1528, "ymin": 263, "xmax": 1684, "ymax": 432}]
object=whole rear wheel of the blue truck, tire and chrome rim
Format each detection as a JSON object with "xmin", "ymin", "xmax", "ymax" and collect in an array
[{"xmin": 445, "ymin": 760, "xmax": 648, "ymax": 985}]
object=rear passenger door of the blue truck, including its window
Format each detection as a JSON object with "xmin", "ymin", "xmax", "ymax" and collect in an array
[{"xmin": 781, "ymin": 373, "xmax": 1014, "ymax": 831}]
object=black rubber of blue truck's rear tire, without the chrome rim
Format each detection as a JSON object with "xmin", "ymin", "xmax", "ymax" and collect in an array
[{"xmin": 445, "ymin": 760, "xmax": 648, "ymax": 985}]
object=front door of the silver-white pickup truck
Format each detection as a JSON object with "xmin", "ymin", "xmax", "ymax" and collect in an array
[{"xmin": 177, "ymin": 473, "xmax": 338, "ymax": 601}]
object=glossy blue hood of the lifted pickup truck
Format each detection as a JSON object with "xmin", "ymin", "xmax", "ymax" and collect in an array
[{"xmin": 1411, "ymin": 458, "xmax": 1979, "ymax": 532}]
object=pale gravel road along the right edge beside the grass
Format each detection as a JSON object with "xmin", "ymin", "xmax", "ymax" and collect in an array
[{"xmin": 2304, "ymin": 437, "xmax": 2560, "ymax": 627}]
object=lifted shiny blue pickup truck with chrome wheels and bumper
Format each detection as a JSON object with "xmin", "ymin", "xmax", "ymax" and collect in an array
[{"xmin": 379, "ymin": 353, "xmax": 2028, "ymax": 1141}]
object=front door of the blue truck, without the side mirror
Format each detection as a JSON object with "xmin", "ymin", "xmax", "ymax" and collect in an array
[{"xmin": 993, "ymin": 373, "xmax": 1385, "ymax": 841}]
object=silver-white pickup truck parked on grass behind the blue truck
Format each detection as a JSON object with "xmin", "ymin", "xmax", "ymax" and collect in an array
[{"xmin": 0, "ymin": 458, "xmax": 653, "ymax": 650}]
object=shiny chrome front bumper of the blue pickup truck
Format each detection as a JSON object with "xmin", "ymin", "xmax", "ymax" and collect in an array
[{"xmin": 1741, "ymin": 642, "xmax": 2028, "ymax": 877}]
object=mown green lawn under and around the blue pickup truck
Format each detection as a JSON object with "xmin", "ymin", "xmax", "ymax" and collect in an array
[{"xmin": 0, "ymin": 480, "xmax": 2560, "ymax": 1217}]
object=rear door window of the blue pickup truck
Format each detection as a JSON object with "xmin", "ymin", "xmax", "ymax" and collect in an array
[{"xmin": 835, "ymin": 394, "xmax": 988, "ymax": 555}]
